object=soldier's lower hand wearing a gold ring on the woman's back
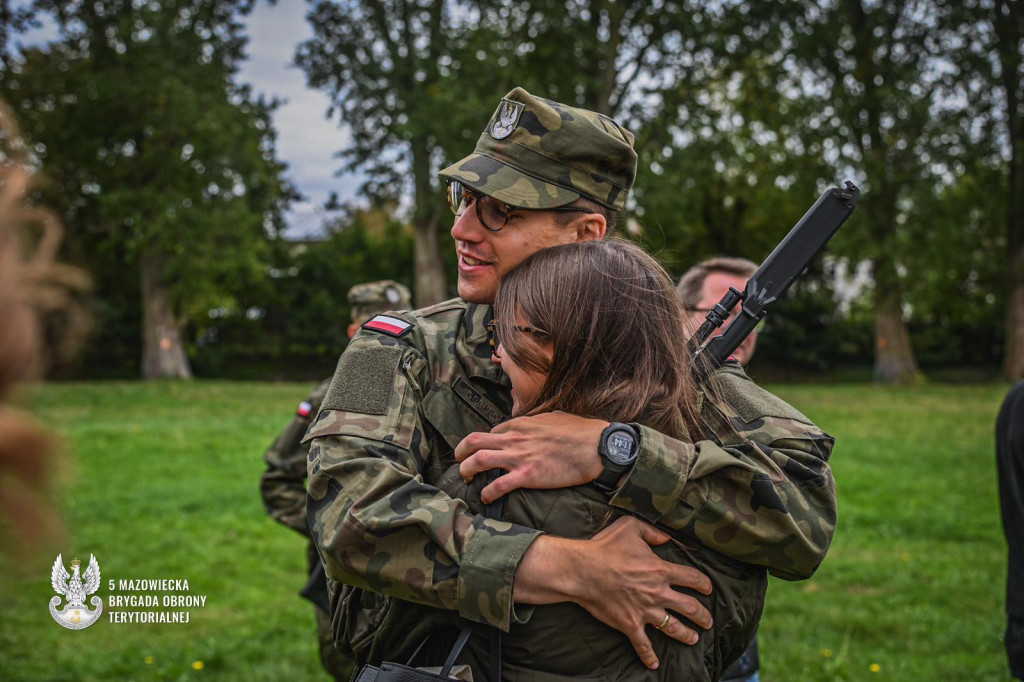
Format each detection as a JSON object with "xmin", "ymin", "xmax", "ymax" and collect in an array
[{"xmin": 515, "ymin": 517, "xmax": 712, "ymax": 670}]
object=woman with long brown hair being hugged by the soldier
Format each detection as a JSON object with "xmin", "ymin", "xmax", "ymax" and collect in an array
[{"xmin": 440, "ymin": 236, "xmax": 767, "ymax": 682}]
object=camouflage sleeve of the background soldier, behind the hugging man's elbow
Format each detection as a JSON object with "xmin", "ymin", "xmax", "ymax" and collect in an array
[{"xmin": 260, "ymin": 381, "xmax": 330, "ymax": 538}]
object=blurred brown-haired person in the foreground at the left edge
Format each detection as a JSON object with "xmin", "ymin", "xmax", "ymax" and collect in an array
[{"xmin": 0, "ymin": 102, "xmax": 88, "ymax": 565}]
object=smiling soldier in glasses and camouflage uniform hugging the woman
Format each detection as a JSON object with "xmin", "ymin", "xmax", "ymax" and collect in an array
[{"xmin": 306, "ymin": 88, "xmax": 836, "ymax": 679}]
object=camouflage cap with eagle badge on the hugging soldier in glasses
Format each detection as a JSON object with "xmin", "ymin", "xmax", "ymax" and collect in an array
[{"xmin": 440, "ymin": 88, "xmax": 637, "ymax": 211}]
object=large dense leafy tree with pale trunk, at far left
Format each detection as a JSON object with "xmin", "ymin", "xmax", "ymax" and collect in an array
[{"xmin": 2, "ymin": 0, "xmax": 293, "ymax": 378}]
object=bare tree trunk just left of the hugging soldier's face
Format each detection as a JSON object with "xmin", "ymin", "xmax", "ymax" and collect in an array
[{"xmin": 413, "ymin": 139, "xmax": 449, "ymax": 308}]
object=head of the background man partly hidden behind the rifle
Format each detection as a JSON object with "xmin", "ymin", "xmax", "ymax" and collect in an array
[{"xmin": 676, "ymin": 257, "xmax": 758, "ymax": 365}]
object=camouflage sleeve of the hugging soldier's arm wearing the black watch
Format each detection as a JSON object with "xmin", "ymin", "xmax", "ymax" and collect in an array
[{"xmin": 611, "ymin": 368, "xmax": 836, "ymax": 580}]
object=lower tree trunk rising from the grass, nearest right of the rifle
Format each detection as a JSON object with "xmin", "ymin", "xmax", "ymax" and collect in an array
[{"xmin": 874, "ymin": 259, "xmax": 921, "ymax": 384}]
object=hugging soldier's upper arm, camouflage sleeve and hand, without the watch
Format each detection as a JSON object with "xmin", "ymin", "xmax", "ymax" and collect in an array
[{"xmin": 456, "ymin": 366, "xmax": 836, "ymax": 580}]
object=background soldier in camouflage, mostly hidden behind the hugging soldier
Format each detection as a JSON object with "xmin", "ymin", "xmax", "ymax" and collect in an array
[{"xmin": 260, "ymin": 280, "xmax": 413, "ymax": 680}]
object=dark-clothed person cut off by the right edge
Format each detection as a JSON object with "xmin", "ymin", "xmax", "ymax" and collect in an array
[{"xmin": 995, "ymin": 381, "xmax": 1024, "ymax": 680}]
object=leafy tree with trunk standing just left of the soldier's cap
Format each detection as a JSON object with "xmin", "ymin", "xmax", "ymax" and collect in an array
[{"xmin": 295, "ymin": 0, "xmax": 495, "ymax": 306}]
